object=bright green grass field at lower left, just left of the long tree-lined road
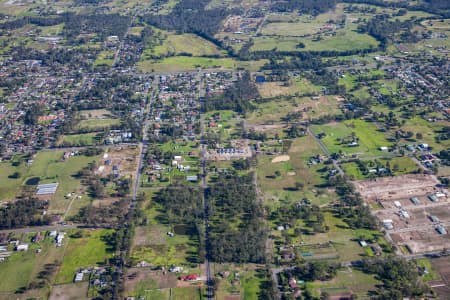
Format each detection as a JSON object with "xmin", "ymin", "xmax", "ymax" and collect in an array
[{"xmin": 56, "ymin": 229, "xmax": 114, "ymax": 283}]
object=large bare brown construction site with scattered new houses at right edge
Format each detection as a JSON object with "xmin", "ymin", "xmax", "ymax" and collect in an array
[{"xmin": 354, "ymin": 174, "xmax": 450, "ymax": 254}]
